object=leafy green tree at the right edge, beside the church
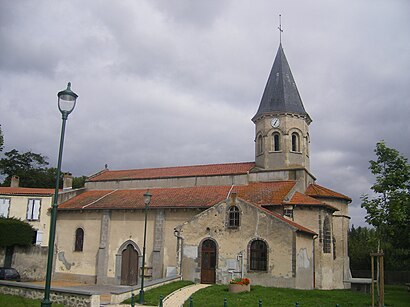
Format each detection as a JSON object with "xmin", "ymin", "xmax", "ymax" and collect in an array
[{"xmin": 361, "ymin": 141, "xmax": 410, "ymax": 262}]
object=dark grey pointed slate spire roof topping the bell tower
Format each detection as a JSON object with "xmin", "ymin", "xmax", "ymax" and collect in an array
[{"xmin": 252, "ymin": 44, "xmax": 311, "ymax": 121}]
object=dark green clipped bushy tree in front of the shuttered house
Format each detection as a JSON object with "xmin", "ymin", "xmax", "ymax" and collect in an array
[{"xmin": 0, "ymin": 217, "xmax": 34, "ymax": 247}]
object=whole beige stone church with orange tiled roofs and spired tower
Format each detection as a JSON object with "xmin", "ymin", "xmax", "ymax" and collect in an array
[{"xmin": 54, "ymin": 44, "xmax": 351, "ymax": 289}]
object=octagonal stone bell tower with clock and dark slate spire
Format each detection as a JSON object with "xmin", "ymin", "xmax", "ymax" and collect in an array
[{"xmin": 252, "ymin": 43, "xmax": 312, "ymax": 172}]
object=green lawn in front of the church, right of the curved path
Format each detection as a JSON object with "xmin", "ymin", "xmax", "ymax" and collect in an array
[{"xmin": 184, "ymin": 285, "xmax": 410, "ymax": 307}]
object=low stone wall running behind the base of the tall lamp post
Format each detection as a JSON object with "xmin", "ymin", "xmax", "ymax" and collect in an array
[{"xmin": 0, "ymin": 281, "xmax": 100, "ymax": 307}]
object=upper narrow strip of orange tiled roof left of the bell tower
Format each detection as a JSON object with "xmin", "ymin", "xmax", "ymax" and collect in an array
[{"xmin": 87, "ymin": 162, "xmax": 255, "ymax": 181}]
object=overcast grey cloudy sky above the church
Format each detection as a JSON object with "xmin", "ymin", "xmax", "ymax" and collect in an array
[{"xmin": 0, "ymin": 0, "xmax": 410, "ymax": 226}]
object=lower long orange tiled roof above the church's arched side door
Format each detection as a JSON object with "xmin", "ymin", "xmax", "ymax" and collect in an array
[{"xmin": 59, "ymin": 181, "xmax": 295, "ymax": 210}]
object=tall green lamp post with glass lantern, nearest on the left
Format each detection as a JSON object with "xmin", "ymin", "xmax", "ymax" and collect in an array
[{"xmin": 41, "ymin": 82, "xmax": 78, "ymax": 306}]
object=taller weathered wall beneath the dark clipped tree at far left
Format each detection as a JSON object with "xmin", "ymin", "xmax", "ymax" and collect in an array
[{"xmin": 0, "ymin": 245, "xmax": 48, "ymax": 281}]
